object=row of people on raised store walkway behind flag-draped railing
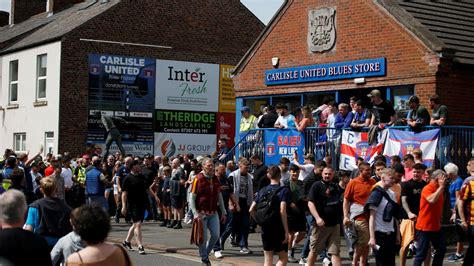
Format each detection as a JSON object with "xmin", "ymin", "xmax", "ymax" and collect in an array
[{"xmin": 240, "ymin": 90, "xmax": 448, "ymax": 132}]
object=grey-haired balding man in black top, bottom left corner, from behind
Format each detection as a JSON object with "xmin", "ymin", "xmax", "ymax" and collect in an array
[{"xmin": 0, "ymin": 189, "xmax": 51, "ymax": 265}]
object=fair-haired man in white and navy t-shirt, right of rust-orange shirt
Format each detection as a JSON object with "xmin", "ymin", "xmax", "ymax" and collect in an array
[{"xmin": 366, "ymin": 168, "xmax": 400, "ymax": 265}]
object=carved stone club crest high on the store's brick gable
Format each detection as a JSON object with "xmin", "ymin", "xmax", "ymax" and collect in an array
[{"xmin": 308, "ymin": 7, "xmax": 336, "ymax": 53}]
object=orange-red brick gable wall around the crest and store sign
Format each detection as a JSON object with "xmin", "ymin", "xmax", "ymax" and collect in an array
[{"xmin": 234, "ymin": 0, "xmax": 439, "ymax": 101}]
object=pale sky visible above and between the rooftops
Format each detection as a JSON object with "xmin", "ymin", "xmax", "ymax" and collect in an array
[{"xmin": 0, "ymin": 0, "xmax": 284, "ymax": 24}]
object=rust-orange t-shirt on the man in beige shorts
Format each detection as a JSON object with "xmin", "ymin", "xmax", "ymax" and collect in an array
[{"xmin": 344, "ymin": 176, "xmax": 375, "ymax": 220}]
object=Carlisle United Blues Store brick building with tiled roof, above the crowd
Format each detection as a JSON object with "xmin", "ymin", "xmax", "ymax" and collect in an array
[{"xmin": 234, "ymin": 0, "xmax": 474, "ymax": 128}]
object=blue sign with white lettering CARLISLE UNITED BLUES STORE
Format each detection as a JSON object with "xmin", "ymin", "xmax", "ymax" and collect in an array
[{"xmin": 265, "ymin": 58, "xmax": 386, "ymax": 85}]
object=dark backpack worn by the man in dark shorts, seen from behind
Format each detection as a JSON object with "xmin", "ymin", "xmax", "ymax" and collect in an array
[{"xmin": 255, "ymin": 187, "xmax": 284, "ymax": 226}]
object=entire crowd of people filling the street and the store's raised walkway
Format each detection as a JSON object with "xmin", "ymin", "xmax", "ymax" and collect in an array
[{"xmin": 0, "ymin": 90, "xmax": 474, "ymax": 266}]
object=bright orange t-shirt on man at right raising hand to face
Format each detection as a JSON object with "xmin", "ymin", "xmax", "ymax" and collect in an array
[{"xmin": 416, "ymin": 182, "xmax": 444, "ymax": 231}]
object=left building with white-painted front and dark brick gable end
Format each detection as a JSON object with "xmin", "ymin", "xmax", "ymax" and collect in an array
[{"xmin": 0, "ymin": 0, "xmax": 264, "ymax": 154}]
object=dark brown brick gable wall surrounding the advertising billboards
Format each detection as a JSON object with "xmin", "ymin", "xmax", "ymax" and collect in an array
[{"xmin": 58, "ymin": 0, "xmax": 263, "ymax": 154}]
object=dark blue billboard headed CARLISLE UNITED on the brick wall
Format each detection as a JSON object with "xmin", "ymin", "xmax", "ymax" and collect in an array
[{"xmin": 87, "ymin": 54, "xmax": 156, "ymax": 155}]
